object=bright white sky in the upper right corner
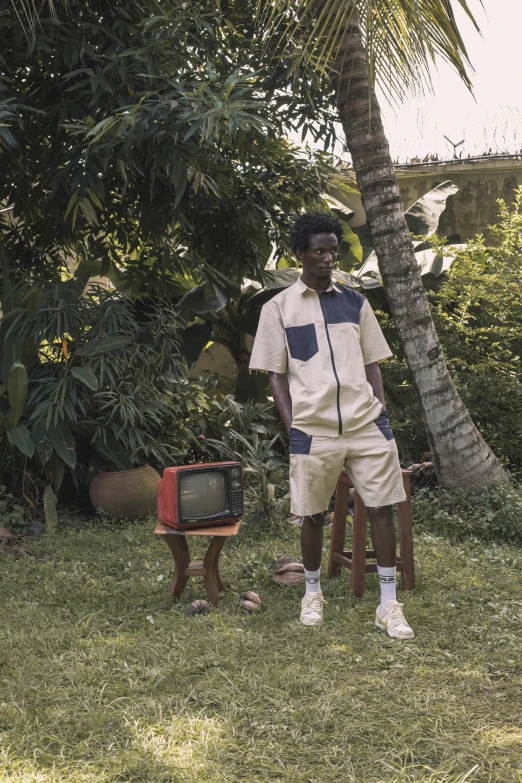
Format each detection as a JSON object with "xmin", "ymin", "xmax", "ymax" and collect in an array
[{"xmin": 294, "ymin": 0, "xmax": 522, "ymax": 163}]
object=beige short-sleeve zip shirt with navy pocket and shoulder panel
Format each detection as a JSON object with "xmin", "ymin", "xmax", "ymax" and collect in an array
[{"xmin": 250, "ymin": 278, "xmax": 392, "ymax": 436}]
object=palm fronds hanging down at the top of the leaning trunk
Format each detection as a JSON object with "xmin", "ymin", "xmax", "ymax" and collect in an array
[{"xmin": 257, "ymin": 0, "xmax": 482, "ymax": 100}]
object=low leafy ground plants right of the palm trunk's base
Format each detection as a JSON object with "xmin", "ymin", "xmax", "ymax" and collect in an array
[{"xmin": 413, "ymin": 485, "xmax": 522, "ymax": 546}]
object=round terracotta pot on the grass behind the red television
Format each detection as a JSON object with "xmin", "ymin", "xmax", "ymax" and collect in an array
[{"xmin": 89, "ymin": 465, "xmax": 160, "ymax": 519}]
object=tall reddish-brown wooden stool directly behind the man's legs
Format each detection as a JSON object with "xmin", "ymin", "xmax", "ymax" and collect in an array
[{"xmin": 328, "ymin": 470, "xmax": 415, "ymax": 598}]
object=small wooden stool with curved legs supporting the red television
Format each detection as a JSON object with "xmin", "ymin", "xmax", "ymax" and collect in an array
[{"xmin": 154, "ymin": 520, "xmax": 241, "ymax": 606}]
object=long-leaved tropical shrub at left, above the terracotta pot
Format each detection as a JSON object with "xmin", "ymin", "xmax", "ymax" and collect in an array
[{"xmin": 0, "ymin": 278, "xmax": 190, "ymax": 500}]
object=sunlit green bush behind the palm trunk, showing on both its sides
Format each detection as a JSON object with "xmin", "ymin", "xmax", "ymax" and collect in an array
[{"xmin": 380, "ymin": 189, "xmax": 522, "ymax": 474}]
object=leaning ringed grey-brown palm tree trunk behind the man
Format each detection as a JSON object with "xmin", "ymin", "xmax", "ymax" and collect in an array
[{"xmin": 335, "ymin": 16, "xmax": 505, "ymax": 487}]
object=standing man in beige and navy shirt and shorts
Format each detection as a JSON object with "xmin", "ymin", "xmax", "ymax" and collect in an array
[{"xmin": 250, "ymin": 214, "xmax": 413, "ymax": 639}]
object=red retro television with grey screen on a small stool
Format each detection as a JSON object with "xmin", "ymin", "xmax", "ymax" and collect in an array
[{"xmin": 158, "ymin": 462, "xmax": 243, "ymax": 530}]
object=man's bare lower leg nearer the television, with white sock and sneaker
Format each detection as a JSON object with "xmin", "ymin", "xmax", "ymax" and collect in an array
[{"xmin": 301, "ymin": 514, "xmax": 324, "ymax": 625}]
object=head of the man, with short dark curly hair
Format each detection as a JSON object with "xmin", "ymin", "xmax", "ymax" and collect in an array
[{"xmin": 290, "ymin": 212, "xmax": 343, "ymax": 280}]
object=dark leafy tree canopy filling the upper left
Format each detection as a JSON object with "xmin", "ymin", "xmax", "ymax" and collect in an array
[{"xmin": 0, "ymin": 0, "xmax": 331, "ymax": 295}]
